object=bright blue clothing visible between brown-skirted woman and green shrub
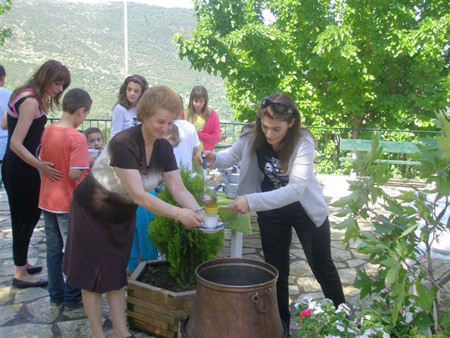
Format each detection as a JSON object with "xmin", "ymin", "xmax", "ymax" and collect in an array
[{"xmin": 128, "ymin": 190, "xmax": 158, "ymax": 271}]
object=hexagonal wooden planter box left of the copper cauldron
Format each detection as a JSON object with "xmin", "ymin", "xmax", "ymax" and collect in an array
[{"xmin": 127, "ymin": 261, "xmax": 196, "ymax": 338}]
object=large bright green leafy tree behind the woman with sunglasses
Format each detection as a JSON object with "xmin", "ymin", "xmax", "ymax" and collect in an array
[{"xmin": 175, "ymin": 0, "xmax": 450, "ymax": 136}]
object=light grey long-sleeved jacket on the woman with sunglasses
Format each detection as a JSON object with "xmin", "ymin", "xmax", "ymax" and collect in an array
[{"xmin": 211, "ymin": 127, "xmax": 328, "ymax": 227}]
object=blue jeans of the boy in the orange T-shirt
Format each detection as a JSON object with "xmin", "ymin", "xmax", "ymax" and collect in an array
[{"xmin": 43, "ymin": 211, "xmax": 81, "ymax": 306}]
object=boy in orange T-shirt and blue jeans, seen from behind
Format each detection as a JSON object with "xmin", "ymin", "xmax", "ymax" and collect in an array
[{"xmin": 39, "ymin": 88, "xmax": 92, "ymax": 310}]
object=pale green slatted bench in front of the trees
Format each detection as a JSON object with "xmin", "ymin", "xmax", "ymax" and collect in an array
[{"xmin": 339, "ymin": 139, "xmax": 420, "ymax": 166}]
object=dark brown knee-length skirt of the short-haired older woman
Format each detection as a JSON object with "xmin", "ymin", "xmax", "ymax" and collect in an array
[{"xmin": 63, "ymin": 199, "xmax": 136, "ymax": 293}]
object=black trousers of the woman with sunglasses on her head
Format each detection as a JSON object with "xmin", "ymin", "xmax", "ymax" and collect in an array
[{"xmin": 258, "ymin": 202, "xmax": 345, "ymax": 327}]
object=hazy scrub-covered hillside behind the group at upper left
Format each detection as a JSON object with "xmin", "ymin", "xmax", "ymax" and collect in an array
[{"xmin": 0, "ymin": 0, "xmax": 231, "ymax": 120}]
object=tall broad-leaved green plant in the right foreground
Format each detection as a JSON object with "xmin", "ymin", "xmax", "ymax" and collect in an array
[{"xmin": 334, "ymin": 114, "xmax": 450, "ymax": 337}]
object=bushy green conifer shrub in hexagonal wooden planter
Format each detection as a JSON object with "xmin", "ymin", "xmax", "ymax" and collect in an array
[{"xmin": 127, "ymin": 169, "xmax": 224, "ymax": 337}]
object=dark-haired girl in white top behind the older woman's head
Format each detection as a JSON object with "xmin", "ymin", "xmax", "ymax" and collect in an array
[{"xmin": 110, "ymin": 75, "xmax": 148, "ymax": 139}]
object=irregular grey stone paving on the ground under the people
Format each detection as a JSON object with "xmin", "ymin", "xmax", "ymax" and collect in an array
[{"xmin": 0, "ymin": 175, "xmax": 448, "ymax": 338}]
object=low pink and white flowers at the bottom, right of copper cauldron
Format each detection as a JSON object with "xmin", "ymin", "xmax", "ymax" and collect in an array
[{"xmin": 294, "ymin": 296, "xmax": 390, "ymax": 338}]
